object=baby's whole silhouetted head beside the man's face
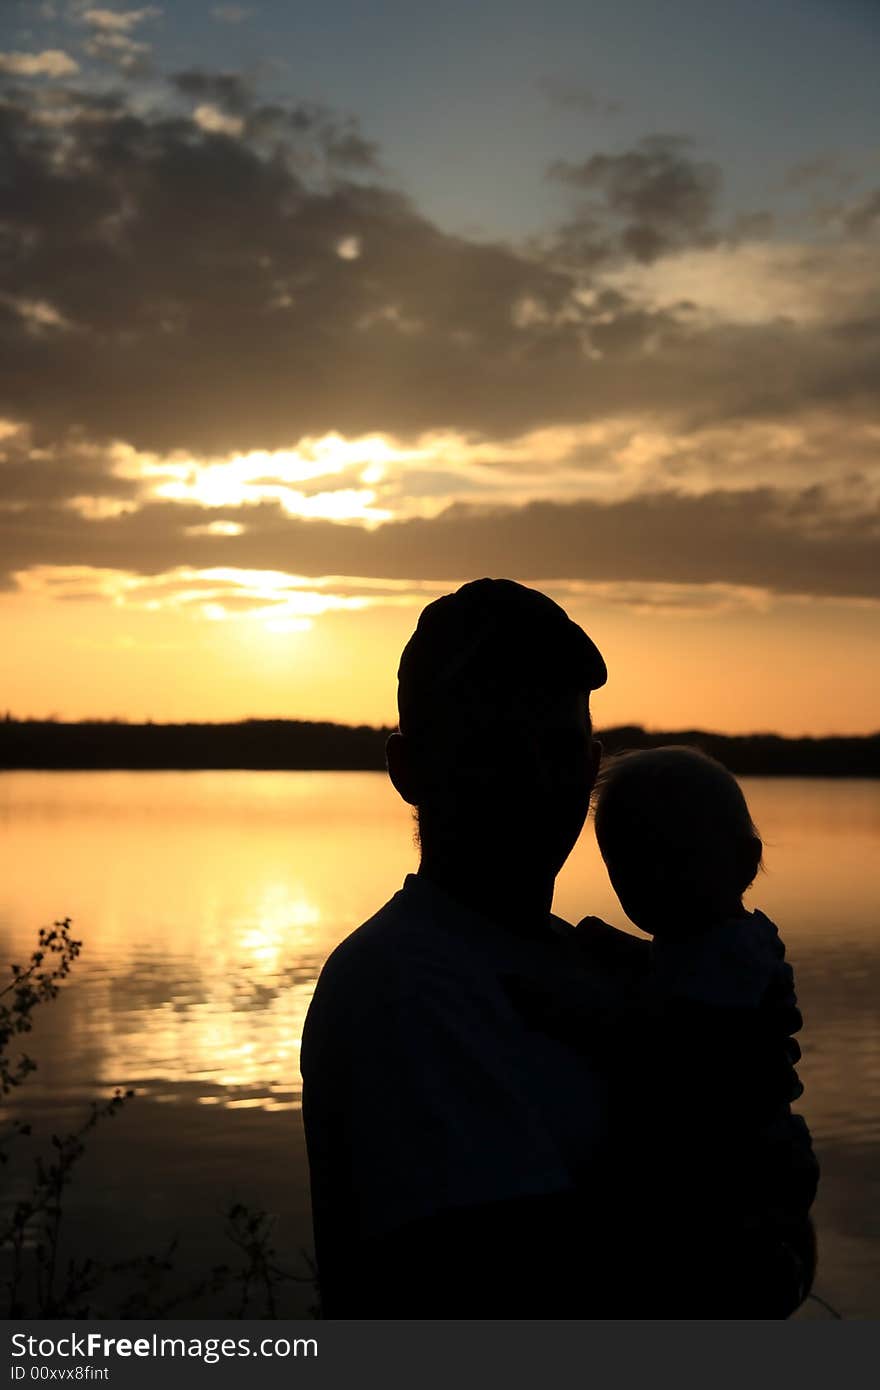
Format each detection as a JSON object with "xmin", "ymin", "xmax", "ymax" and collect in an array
[{"xmin": 595, "ymin": 746, "xmax": 763, "ymax": 935}]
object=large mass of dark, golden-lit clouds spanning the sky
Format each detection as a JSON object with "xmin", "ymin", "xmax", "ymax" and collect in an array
[{"xmin": 0, "ymin": 76, "xmax": 880, "ymax": 619}]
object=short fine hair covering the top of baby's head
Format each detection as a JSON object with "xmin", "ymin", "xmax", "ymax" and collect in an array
[{"xmin": 594, "ymin": 744, "xmax": 763, "ymax": 897}]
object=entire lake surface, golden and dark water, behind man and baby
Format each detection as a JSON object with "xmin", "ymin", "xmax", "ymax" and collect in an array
[{"xmin": 0, "ymin": 771, "xmax": 880, "ymax": 1318}]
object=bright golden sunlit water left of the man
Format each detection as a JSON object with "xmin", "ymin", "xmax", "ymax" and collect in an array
[{"xmin": 0, "ymin": 773, "xmax": 412, "ymax": 1109}]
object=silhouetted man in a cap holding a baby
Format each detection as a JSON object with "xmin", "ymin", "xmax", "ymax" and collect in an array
[{"xmin": 302, "ymin": 580, "xmax": 811, "ymax": 1318}]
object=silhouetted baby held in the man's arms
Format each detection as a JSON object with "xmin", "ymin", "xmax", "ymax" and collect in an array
[{"xmin": 577, "ymin": 746, "xmax": 817, "ymax": 1316}]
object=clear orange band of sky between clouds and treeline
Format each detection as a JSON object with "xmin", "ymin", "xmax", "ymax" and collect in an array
[{"xmin": 0, "ymin": 564, "xmax": 880, "ymax": 734}]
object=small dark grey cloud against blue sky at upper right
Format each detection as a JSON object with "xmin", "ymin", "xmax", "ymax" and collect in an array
[{"xmin": 549, "ymin": 135, "xmax": 722, "ymax": 263}]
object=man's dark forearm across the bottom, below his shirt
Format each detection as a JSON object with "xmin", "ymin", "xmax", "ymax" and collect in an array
[{"xmin": 343, "ymin": 1167, "xmax": 816, "ymax": 1319}]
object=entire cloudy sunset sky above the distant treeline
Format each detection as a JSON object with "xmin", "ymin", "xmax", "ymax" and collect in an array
[{"xmin": 0, "ymin": 0, "xmax": 880, "ymax": 734}]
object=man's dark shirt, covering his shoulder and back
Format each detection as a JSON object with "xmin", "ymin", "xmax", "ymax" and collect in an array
[{"xmin": 302, "ymin": 874, "xmax": 617, "ymax": 1282}]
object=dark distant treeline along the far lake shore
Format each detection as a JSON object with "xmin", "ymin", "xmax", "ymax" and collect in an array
[{"xmin": 0, "ymin": 716, "xmax": 880, "ymax": 777}]
